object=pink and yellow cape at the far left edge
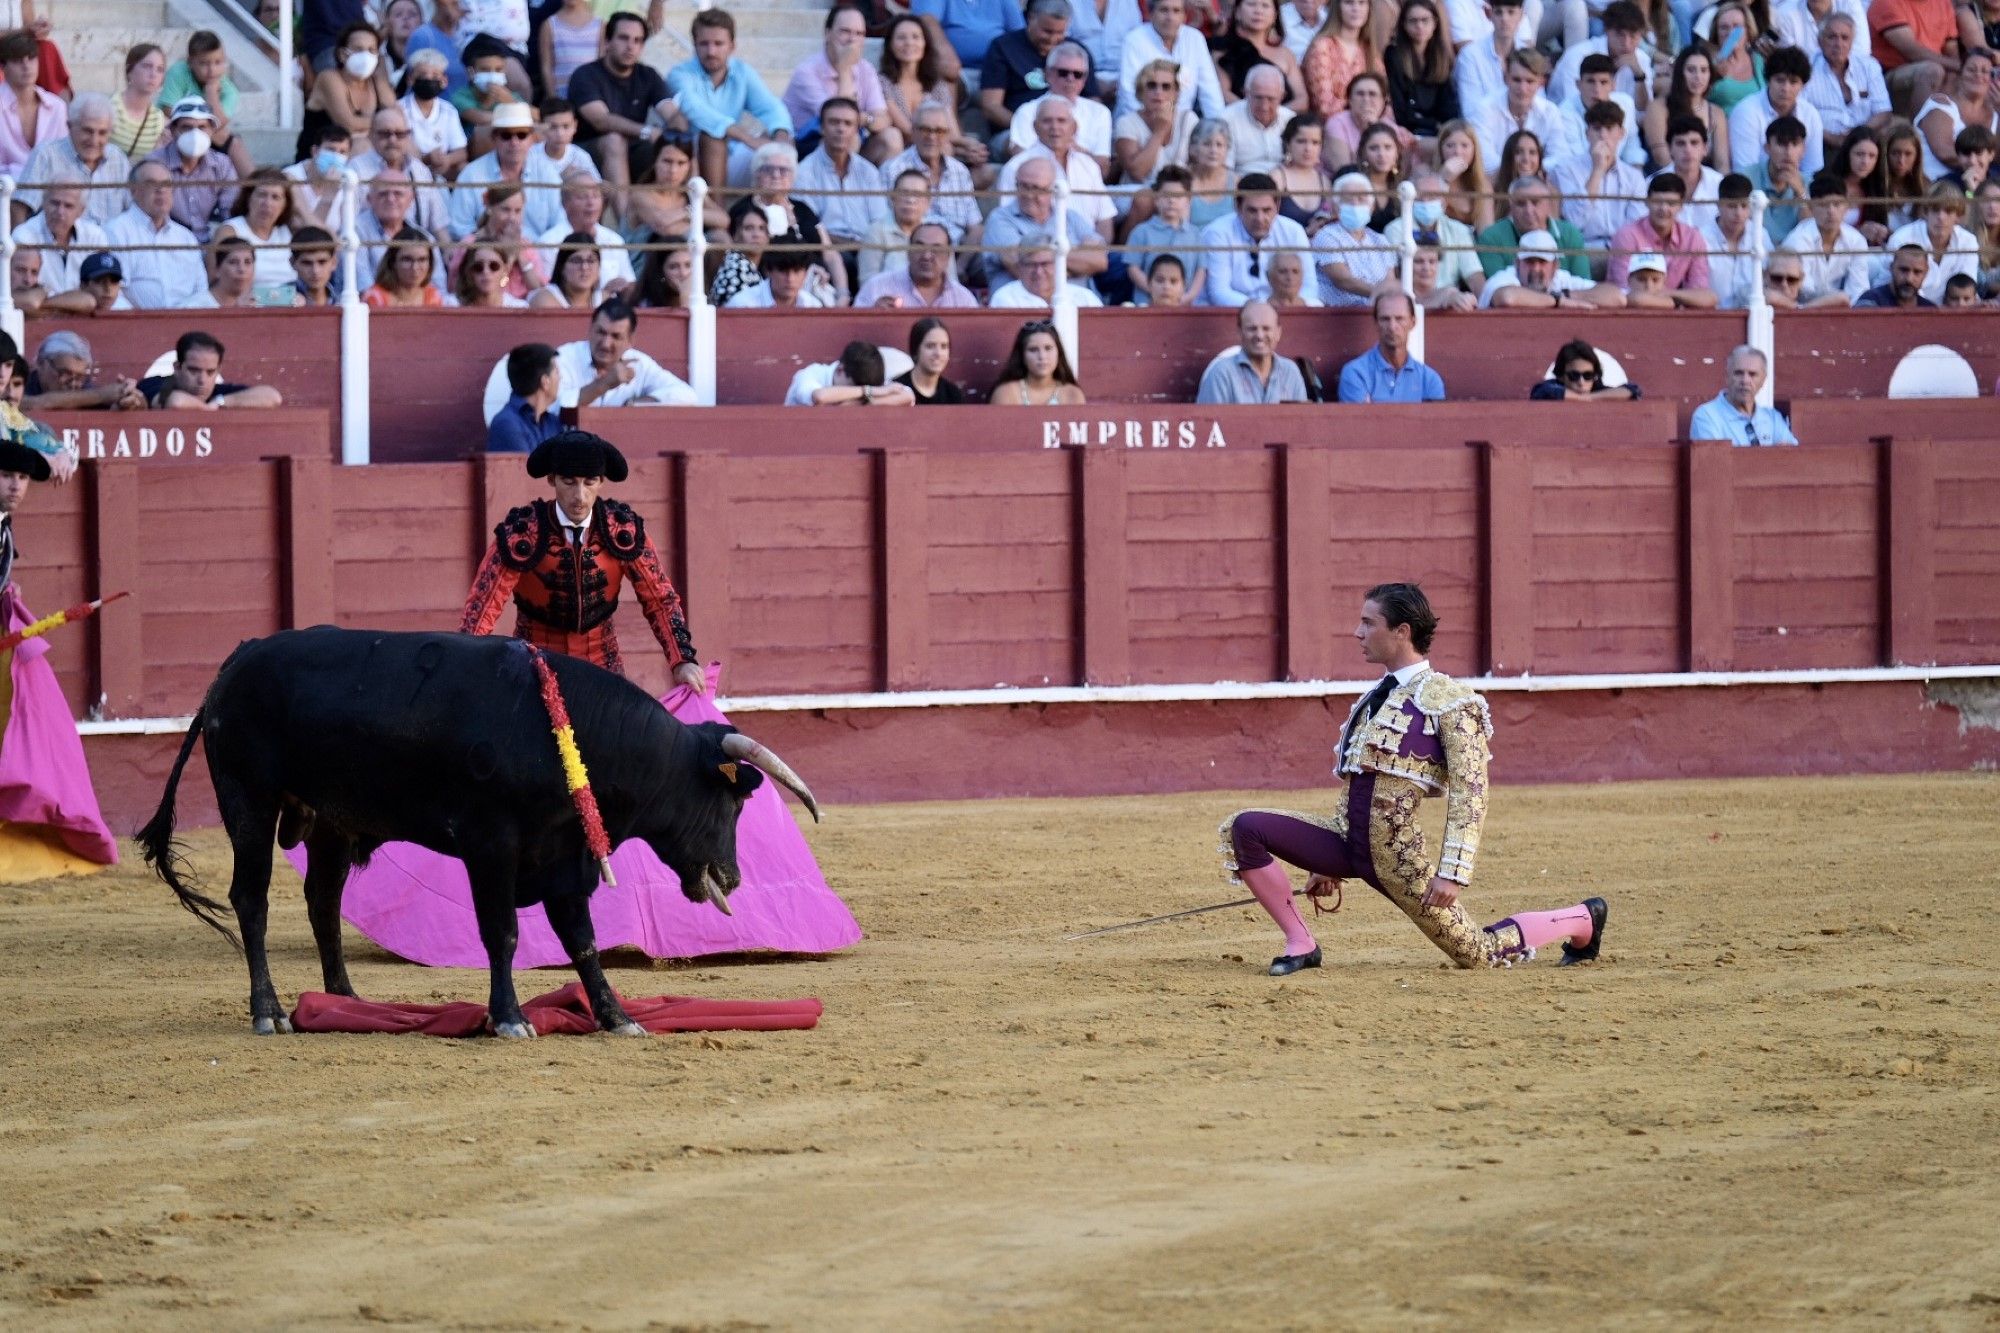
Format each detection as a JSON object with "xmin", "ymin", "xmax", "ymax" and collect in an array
[{"xmin": 0, "ymin": 584, "xmax": 117, "ymax": 865}]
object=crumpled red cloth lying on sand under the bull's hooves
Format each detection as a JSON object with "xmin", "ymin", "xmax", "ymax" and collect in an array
[{"xmin": 292, "ymin": 981, "xmax": 822, "ymax": 1037}]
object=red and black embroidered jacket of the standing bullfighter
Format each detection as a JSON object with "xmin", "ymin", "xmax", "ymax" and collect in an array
[{"xmin": 458, "ymin": 500, "xmax": 698, "ymax": 671}]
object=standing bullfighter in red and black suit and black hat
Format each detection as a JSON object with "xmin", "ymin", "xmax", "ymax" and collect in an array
[{"xmin": 458, "ymin": 430, "xmax": 708, "ymax": 693}]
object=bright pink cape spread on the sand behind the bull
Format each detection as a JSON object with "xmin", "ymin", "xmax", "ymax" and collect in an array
[{"xmin": 288, "ymin": 667, "xmax": 862, "ymax": 967}]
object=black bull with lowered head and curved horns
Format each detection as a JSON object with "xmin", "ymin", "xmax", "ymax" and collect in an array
[{"xmin": 138, "ymin": 626, "xmax": 820, "ymax": 1037}]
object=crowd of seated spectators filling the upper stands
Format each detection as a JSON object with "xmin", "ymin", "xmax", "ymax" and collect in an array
[{"xmin": 0, "ymin": 0, "xmax": 2000, "ymax": 326}]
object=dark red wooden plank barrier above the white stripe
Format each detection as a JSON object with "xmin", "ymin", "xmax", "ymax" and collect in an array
[{"xmin": 18, "ymin": 438, "xmax": 2000, "ymax": 717}]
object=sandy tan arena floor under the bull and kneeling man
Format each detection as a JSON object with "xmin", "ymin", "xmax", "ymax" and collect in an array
[{"xmin": 0, "ymin": 775, "xmax": 2000, "ymax": 1329}]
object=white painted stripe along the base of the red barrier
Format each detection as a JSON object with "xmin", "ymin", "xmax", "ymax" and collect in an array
[{"xmin": 76, "ymin": 664, "xmax": 2000, "ymax": 737}]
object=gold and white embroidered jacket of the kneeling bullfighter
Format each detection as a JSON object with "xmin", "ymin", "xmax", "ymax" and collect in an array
[{"xmin": 1334, "ymin": 671, "xmax": 1494, "ymax": 885}]
